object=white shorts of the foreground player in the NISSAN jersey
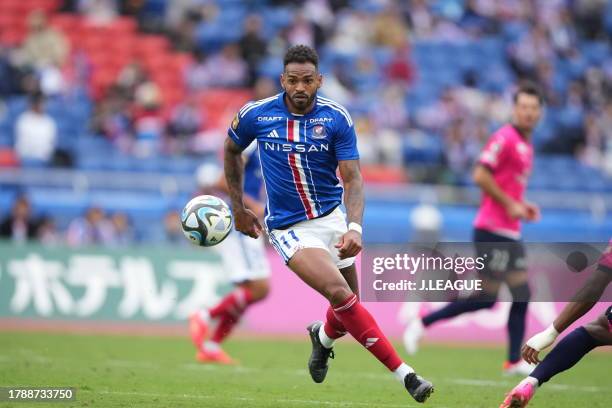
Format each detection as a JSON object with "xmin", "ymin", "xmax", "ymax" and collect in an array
[{"xmin": 268, "ymin": 207, "xmax": 355, "ymax": 269}]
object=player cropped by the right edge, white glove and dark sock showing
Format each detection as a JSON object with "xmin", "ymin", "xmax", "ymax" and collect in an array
[{"xmin": 500, "ymin": 240, "xmax": 612, "ymax": 408}]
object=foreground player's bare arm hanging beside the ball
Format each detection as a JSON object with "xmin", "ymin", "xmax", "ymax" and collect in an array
[{"xmin": 223, "ymin": 138, "xmax": 262, "ymax": 238}]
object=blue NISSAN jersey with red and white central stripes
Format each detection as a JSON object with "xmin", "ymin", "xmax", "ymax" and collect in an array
[{"xmin": 228, "ymin": 92, "xmax": 359, "ymax": 229}]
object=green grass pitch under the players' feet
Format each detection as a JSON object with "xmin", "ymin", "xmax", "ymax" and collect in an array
[{"xmin": 0, "ymin": 332, "xmax": 612, "ymax": 408}]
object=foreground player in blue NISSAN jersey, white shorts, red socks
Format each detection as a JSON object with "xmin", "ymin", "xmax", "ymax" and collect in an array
[{"xmin": 225, "ymin": 45, "xmax": 433, "ymax": 402}]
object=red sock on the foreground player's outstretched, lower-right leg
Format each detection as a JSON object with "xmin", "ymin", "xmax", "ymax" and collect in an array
[{"xmin": 334, "ymin": 294, "xmax": 402, "ymax": 371}]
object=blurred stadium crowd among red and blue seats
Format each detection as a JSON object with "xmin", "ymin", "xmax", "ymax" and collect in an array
[{"xmin": 0, "ymin": 0, "xmax": 612, "ymax": 241}]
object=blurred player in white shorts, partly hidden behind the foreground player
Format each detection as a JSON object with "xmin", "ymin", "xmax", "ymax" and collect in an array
[{"xmin": 189, "ymin": 143, "xmax": 270, "ymax": 364}]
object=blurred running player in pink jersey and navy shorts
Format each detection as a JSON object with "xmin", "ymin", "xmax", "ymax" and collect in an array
[{"xmin": 404, "ymin": 84, "xmax": 543, "ymax": 374}]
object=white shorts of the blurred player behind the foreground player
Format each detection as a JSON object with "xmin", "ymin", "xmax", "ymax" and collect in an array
[{"xmin": 213, "ymin": 231, "xmax": 270, "ymax": 283}]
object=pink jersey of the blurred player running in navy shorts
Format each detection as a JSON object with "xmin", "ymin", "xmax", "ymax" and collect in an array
[{"xmin": 474, "ymin": 125, "xmax": 533, "ymax": 239}]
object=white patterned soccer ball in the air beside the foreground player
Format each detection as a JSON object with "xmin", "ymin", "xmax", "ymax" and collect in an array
[{"xmin": 181, "ymin": 195, "xmax": 233, "ymax": 246}]
